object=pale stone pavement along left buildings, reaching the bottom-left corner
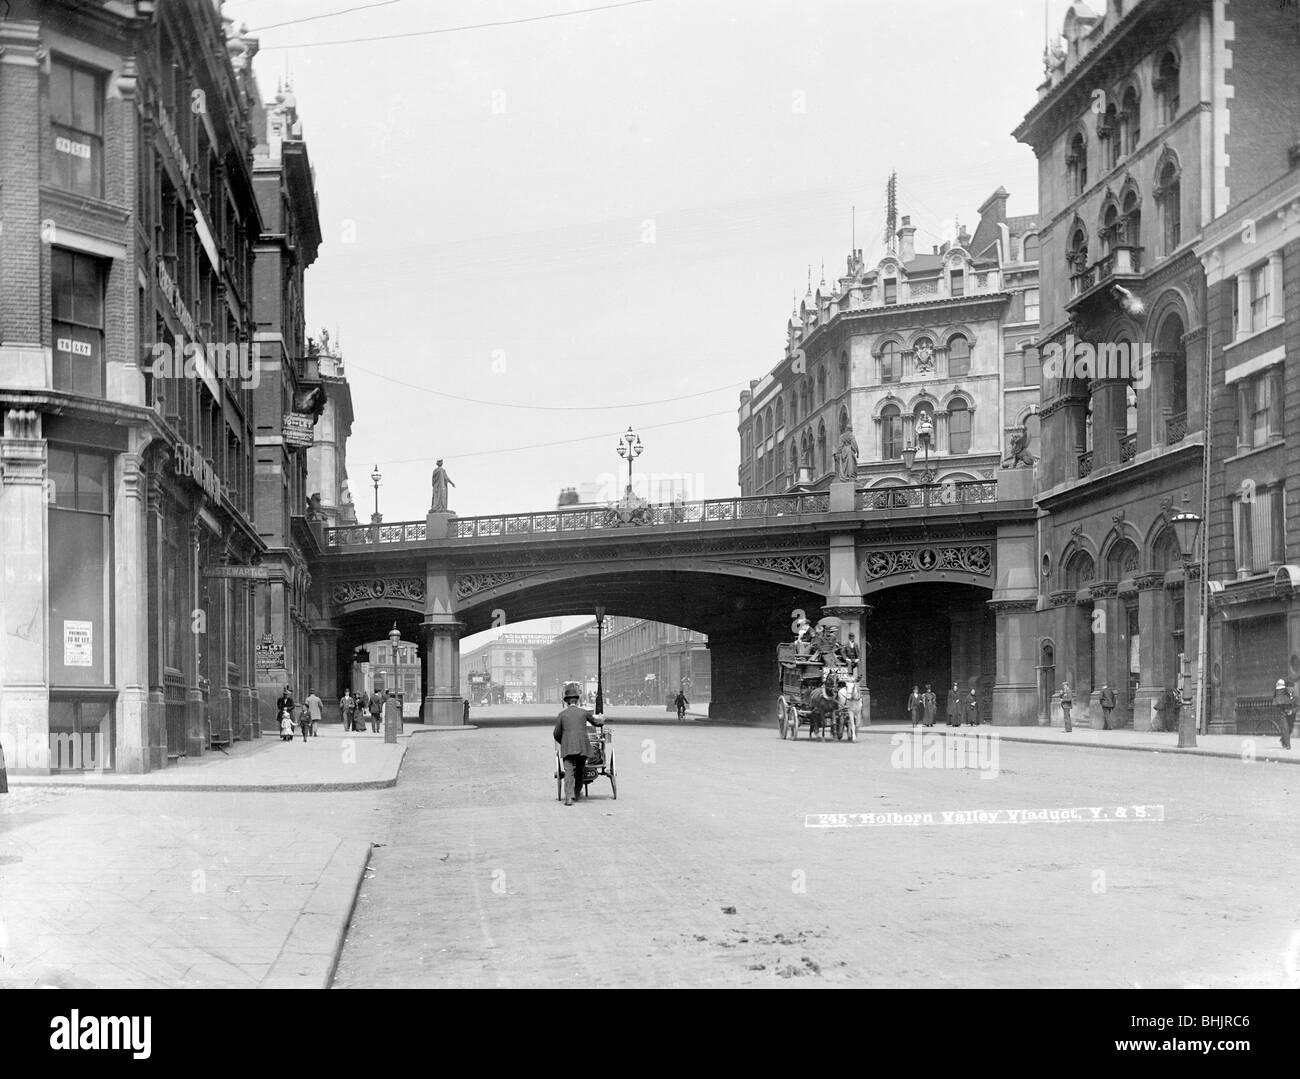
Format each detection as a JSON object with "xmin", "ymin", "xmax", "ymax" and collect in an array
[{"xmin": 0, "ymin": 724, "xmax": 469, "ymax": 989}]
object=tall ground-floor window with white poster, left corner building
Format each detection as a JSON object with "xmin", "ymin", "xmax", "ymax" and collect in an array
[{"xmin": 48, "ymin": 446, "xmax": 113, "ymax": 686}]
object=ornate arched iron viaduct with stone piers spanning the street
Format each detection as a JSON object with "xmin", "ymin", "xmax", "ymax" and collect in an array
[{"xmin": 301, "ymin": 469, "xmax": 1037, "ymax": 724}]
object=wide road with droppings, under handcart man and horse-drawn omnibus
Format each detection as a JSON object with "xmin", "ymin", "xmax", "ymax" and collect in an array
[{"xmin": 334, "ymin": 706, "xmax": 1300, "ymax": 988}]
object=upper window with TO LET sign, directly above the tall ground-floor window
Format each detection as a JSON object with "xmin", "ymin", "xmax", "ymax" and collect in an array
[{"xmin": 51, "ymin": 247, "xmax": 104, "ymax": 398}]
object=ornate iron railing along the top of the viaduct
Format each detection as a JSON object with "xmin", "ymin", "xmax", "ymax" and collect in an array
[{"xmin": 326, "ymin": 480, "xmax": 997, "ymax": 547}]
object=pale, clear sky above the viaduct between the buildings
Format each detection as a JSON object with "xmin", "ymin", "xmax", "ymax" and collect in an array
[{"xmin": 226, "ymin": 0, "xmax": 1065, "ymax": 647}]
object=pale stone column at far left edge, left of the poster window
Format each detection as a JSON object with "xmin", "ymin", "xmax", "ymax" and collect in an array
[{"xmin": 0, "ymin": 410, "xmax": 49, "ymax": 775}]
